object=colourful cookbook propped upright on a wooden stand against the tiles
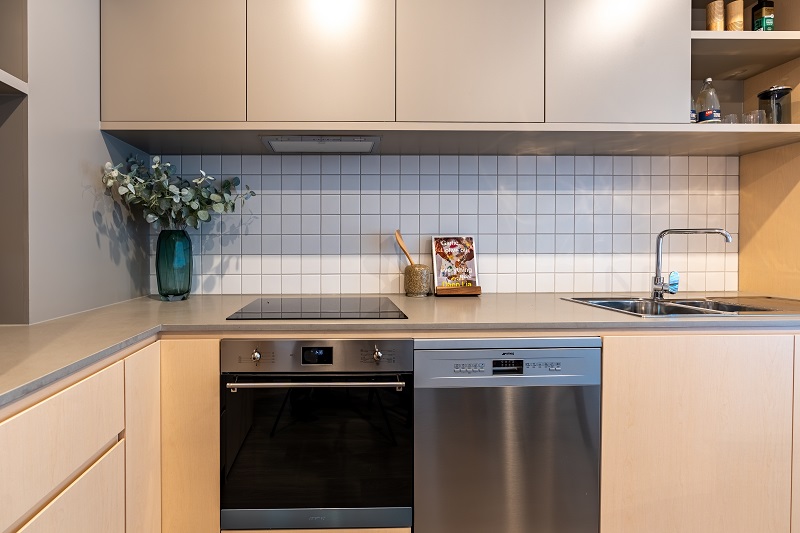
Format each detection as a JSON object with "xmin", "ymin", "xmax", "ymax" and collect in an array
[{"xmin": 433, "ymin": 236, "xmax": 481, "ymax": 296}]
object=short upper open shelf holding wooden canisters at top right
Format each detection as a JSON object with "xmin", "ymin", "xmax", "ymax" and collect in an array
[{"xmin": 692, "ymin": 31, "xmax": 800, "ymax": 80}]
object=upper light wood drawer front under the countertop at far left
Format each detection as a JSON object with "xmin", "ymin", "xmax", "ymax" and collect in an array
[{"xmin": 0, "ymin": 362, "xmax": 125, "ymax": 531}]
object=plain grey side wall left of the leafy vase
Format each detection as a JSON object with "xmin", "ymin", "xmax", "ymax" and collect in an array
[{"xmin": 28, "ymin": 0, "xmax": 147, "ymax": 322}]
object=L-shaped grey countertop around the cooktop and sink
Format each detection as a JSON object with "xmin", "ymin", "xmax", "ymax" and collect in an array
[{"xmin": 0, "ymin": 293, "xmax": 800, "ymax": 407}]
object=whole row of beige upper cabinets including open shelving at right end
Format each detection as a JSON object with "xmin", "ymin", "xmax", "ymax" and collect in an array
[{"xmin": 97, "ymin": 0, "xmax": 800, "ymax": 156}]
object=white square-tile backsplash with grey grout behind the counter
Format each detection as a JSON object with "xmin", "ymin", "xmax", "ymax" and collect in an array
[{"xmin": 150, "ymin": 155, "xmax": 739, "ymax": 294}]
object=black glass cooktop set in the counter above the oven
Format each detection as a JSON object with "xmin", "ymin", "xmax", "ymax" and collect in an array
[{"xmin": 228, "ymin": 296, "xmax": 408, "ymax": 320}]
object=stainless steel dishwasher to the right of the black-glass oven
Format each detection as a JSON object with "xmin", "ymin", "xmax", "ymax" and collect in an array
[{"xmin": 414, "ymin": 337, "xmax": 601, "ymax": 533}]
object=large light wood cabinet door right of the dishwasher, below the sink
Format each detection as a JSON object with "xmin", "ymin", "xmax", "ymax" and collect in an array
[{"xmin": 600, "ymin": 335, "xmax": 794, "ymax": 533}]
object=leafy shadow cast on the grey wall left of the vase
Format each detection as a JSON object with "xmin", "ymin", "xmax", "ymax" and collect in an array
[{"xmin": 86, "ymin": 133, "xmax": 150, "ymax": 294}]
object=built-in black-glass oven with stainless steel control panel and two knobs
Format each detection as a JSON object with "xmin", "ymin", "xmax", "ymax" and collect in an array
[{"xmin": 220, "ymin": 339, "xmax": 414, "ymax": 530}]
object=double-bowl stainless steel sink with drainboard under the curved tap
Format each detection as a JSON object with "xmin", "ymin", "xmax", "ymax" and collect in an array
[{"xmin": 564, "ymin": 296, "xmax": 800, "ymax": 317}]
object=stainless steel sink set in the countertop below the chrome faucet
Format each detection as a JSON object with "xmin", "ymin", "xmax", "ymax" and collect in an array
[{"xmin": 564, "ymin": 297, "xmax": 784, "ymax": 317}]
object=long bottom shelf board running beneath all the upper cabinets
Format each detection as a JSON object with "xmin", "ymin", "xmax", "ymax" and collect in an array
[{"xmin": 101, "ymin": 122, "xmax": 800, "ymax": 156}]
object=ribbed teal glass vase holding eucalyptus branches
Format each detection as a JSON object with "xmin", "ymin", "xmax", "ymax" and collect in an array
[{"xmin": 156, "ymin": 229, "xmax": 192, "ymax": 301}]
